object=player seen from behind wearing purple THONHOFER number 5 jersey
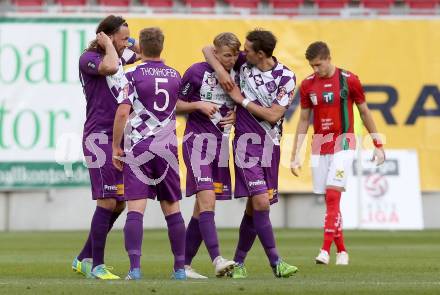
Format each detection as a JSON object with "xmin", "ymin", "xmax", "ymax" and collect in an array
[{"xmin": 113, "ymin": 28, "xmax": 186, "ymax": 280}]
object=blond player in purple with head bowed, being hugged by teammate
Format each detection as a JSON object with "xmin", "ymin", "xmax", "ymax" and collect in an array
[{"xmin": 177, "ymin": 33, "xmax": 241, "ymax": 279}]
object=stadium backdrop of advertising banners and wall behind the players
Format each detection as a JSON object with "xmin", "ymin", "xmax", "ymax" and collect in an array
[{"xmin": 0, "ymin": 1, "xmax": 440, "ymax": 231}]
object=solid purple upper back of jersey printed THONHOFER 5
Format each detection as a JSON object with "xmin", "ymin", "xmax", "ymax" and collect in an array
[{"xmin": 127, "ymin": 61, "xmax": 180, "ymax": 122}]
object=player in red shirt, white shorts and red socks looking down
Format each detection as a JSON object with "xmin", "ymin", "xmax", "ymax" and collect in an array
[{"xmin": 291, "ymin": 41, "xmax": 385, "ymax": 265}]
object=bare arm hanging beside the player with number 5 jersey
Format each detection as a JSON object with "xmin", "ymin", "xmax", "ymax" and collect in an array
[{"xmin": 112, "ymin": 104, "xmax": 131, "ymax": 171}]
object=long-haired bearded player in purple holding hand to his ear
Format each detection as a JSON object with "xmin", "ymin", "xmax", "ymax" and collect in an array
[{"xmin": 72, "ymin": 15, "xmax": 137, "ymax": 279}]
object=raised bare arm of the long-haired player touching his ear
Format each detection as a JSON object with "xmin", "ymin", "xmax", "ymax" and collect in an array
[{"xmin": 96, "ymin": 32, "xmax": 119, "ymax": 76}]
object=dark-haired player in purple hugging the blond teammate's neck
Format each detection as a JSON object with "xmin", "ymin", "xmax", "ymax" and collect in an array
[{"xmin": 204, "ymin": 29, "xmax": 298, "ymax": 278}]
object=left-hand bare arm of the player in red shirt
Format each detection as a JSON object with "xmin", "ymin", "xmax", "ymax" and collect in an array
[{"xmin": 290, "ymin": 109, "xmax": 312, "ymax": 177}]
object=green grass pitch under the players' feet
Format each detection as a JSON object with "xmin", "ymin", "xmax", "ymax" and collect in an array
[{"xmin": 0, "ymin": 229, "xmax": 440, "ymax": 295}]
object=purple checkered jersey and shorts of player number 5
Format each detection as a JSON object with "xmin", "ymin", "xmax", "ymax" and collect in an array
[{"xmin": 122, "ymin": 61, "xmax": 181, "ymax": 201}]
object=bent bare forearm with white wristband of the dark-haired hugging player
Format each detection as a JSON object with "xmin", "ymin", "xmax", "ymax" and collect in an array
[{"xmin": 229, "ymin": 86, "xmax": 287, "ymax": 125}]
